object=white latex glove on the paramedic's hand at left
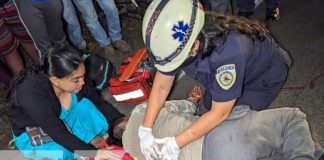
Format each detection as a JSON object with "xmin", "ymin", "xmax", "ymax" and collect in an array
[{"xmin": 138, "ymin": 125, "xmax": 160, "ymax": 160}]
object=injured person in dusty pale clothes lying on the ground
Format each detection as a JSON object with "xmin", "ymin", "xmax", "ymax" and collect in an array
[{"xmin": 119, "ymin": 87, "xmax": 324, "ymax": 160}]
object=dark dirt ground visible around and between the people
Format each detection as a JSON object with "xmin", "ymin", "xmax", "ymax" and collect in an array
[{"xmin": 0, "ymin": 0, "xmax": 324, "ymax": 160}]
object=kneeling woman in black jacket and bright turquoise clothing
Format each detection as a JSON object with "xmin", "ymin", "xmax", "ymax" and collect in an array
[{"xmin": 8, "ymin": 48, "xmax": 124, "ymax": 159}]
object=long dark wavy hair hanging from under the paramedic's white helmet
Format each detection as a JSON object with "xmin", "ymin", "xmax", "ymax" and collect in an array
[{"xmin": 198, "ymin": 12, "xmax": 269, "ymax": 58}]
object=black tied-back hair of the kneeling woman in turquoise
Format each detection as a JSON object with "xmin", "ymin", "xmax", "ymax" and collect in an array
[{"xmin": 6, "ymin": 47, "xmax": 83, "ymax": 108}]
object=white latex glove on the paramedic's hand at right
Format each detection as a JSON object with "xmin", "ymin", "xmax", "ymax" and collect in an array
[{"xmin": 155, "ymin": 137, "xmax": 180, "ymax": 160}]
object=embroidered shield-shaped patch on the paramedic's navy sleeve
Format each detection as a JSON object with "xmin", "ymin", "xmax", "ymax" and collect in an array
[{"xmin": 215, "ymin": 64, "xmax": 236, "ymax": 90}]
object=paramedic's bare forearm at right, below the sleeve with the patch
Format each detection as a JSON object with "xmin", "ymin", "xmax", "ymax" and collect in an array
[{"xmin": 176, "ymin": 99, "xmax": 236, "ymax": 148}]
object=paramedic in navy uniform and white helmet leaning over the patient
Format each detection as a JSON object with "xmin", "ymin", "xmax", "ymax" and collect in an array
[{"xmin": 138, "ymin": 0, "xmax": 291, "ymax": 160}]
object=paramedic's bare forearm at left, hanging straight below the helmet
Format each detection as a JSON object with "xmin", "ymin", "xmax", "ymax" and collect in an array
[{"xmin": 143, "ymin": 71, "xmax": 174, "ymax": 128}]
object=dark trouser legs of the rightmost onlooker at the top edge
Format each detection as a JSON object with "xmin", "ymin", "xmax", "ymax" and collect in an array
[{"xmin": 237, "ymin": 0, "xmax": 280, "ymax": 12}]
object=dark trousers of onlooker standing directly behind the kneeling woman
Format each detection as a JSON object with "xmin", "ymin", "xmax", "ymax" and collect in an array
[{"xmin": 14, "ymin": 0, "xmax": 68, "ymax": 60}]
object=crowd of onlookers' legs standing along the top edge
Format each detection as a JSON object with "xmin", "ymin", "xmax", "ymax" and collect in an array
[{"xmin": 0, "ymin": 0, "xmax": 279, "ymax": 87}]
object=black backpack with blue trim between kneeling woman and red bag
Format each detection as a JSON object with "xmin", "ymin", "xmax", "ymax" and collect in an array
[{"xmin": 83, "ymin": 54, "xmax": 116, "ymax": 90}]
